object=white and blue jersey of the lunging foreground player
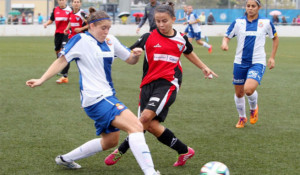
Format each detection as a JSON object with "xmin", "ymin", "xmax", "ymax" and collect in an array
[{"xmin": 61, "ymin": 32, "xmax": 130, "ymax": 107}]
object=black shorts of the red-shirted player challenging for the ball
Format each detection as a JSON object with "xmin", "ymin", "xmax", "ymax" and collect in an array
[{"xmin": 139, "ymin": 79, "xmax": 177, "ymax": 122}]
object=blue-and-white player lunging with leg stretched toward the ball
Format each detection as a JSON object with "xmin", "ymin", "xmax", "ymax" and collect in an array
[{"xmin": 26, "ymin": 11, "xmax": 157, "ymax": 175}]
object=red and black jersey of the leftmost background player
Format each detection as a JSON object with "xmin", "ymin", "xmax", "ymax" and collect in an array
[{"xmin": 50, "ymin": 6, "xmax": 72, "ymax": 33}]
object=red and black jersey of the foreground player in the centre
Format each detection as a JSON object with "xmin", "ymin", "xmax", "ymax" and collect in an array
[{"xmin": 130, "ymin": 29, "xmax": 193, "ymax": 87}]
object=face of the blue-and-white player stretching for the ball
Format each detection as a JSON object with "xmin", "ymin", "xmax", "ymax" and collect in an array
[{"xmin": 90, "ymin": 20, "xmax": 111, "ymax": 42}]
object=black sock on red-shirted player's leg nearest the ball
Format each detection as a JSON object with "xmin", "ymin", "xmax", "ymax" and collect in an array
[{"xmin": 157, "ymin": 128, "xmax": 188, "ymax": 154}]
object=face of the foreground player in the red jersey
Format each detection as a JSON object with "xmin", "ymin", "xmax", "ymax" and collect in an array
[{"xmin": 155, "ymin": 12, "xmax": 176, "ymax": 36}]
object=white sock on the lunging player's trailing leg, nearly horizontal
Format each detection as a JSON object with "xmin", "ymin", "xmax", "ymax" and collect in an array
[{"xmin": 62, "ymin": 138, "xmax": 102, "ymax": 162}]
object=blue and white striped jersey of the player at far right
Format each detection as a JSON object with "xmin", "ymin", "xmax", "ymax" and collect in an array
[{"xmin": 225, "ymin": 16, "xmax": 277, "ymax": 65}]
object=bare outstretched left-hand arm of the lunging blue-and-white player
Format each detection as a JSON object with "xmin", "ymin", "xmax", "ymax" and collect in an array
[{"xmin": 26, "ymin": 56, "xmax": 68, "ymax": 88}]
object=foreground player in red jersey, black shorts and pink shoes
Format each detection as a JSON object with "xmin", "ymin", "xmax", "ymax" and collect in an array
[{"xmin": 105, "ymin": 3, "xmax": 217, "ymax": 166}]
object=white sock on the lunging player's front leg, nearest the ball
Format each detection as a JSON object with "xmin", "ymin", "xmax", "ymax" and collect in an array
[{"xmin": 129, "ymin": 132, "xmax": 155, "ymax": 175}]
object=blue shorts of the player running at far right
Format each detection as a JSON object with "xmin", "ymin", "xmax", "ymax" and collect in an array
[{"xmin": 232, "ymin": 63, "xmax": 266, "ymax": 85}]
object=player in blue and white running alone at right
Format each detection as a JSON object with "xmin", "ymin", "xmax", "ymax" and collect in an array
[{"xmin": 221, "ymin": 0, "xmax": 279, "ymax": 128}]
